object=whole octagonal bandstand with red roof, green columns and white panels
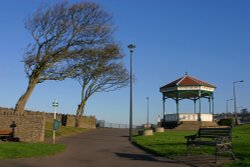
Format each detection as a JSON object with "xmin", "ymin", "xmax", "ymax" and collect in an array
[{"xmin": 160, "ymin": 74, "xmax": 216, "ymax": 125}]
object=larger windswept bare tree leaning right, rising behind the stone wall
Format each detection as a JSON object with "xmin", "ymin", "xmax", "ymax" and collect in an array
[{"xmin": 15, "ymin": 2, "xmax": 113, "ymax": 112}]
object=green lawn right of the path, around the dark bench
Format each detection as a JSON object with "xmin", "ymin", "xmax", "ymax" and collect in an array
[{"xmin": 133, "ymin": 124, "xmax": 250, "ymax": 167}]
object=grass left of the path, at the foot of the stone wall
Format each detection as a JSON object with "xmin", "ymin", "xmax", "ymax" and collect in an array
[{"xmin": 0, "ymin": 123, "xmax": 86, "ymax": 159}]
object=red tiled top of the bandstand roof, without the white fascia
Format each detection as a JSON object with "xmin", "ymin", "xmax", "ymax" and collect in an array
[{"xmin": 160, "ymin": 75, "xmax": 216, "ymax": 89}]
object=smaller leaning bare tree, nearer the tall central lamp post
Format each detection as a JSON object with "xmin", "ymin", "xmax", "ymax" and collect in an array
[{"xmin": 74, "ymin": 45, "xmax": 129, "ymax": 127}]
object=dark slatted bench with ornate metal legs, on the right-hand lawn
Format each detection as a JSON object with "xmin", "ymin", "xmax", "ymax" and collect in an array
[{"xmin": 185, "ymin": 127, "xmax": 236, "ymax": 161}]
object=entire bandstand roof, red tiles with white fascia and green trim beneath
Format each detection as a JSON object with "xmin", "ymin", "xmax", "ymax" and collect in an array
[{"xmin": 160, "ymin": 74, "xmax": 216, "ymax": 99}]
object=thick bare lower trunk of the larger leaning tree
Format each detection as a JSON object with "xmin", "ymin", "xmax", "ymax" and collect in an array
[{"xmin": 15, "ymin": 78, "xmax": 38, "ymax": 114}]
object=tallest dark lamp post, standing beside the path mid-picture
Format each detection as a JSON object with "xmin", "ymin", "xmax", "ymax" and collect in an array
[{"xmin": 128, "ymin": 44, "xmax": 135, "ymax": 142}]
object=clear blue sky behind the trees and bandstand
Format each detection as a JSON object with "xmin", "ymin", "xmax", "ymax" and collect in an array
[{"xmin": 0, "ymin": 0, "xmax": 250, "ymax": 124}]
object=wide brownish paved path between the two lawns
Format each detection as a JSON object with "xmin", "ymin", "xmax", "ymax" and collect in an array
[{"xmin": 0, "ymin": 129, "xmax": 201, "ymax": 167}]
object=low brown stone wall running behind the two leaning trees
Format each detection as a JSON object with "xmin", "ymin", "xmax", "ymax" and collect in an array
[{"xmin": 0, "ymin": 107, "xmax": 96, "ymax": 142}]
